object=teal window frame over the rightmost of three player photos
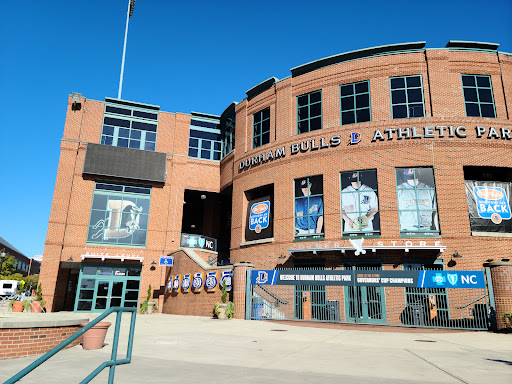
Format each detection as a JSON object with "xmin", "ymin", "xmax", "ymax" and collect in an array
[{"xmin": 395, "ymin": 167, "xmax": 441, "ymax": 238}]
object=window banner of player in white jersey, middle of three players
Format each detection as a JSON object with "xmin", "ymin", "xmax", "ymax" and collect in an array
[{"xmin": 340, "ymin": 170, "xmax": 380, "ymax": 237}]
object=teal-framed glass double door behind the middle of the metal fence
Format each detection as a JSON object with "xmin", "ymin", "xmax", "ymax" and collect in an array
[{"xmin": 345, "ymin": 265, "xmax": 386, "ymax": 324}]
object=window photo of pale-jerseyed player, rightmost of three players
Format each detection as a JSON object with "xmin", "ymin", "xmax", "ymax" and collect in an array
[{"xmin": 396, "ymin": 168, "xmax": 439, "ymax": 232}]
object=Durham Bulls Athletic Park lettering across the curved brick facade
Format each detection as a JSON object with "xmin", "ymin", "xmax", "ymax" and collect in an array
[{"xmin": 238, "ymin": 125, "xmax": 512, "ymax": 172}]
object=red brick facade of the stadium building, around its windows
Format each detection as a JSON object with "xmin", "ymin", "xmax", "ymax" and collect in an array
[{"xmin": 40, "ymin": 50, "xmax": 512, "ymax": 315}]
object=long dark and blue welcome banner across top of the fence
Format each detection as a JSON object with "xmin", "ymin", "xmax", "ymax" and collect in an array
[{"xmin": 251, "ymin": 269, "xmax": 485, "ymax": 288}]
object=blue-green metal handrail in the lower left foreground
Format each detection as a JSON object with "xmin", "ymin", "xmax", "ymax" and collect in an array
[{"xmin": 4, "ymin": 307, "xmax": 137, "ymax": 384}]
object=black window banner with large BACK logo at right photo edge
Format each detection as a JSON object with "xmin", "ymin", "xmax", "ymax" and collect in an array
[{"xmin": 465, "ymin": 180, "xmax": 512, "ymax": 233}]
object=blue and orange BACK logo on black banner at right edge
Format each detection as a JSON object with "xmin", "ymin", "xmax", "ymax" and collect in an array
[{"xmin": 473, "ymin": 187, "xmax": 511, "ymax": 224}]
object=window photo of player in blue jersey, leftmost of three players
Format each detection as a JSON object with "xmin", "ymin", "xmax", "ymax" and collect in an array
[{"xmin": 295, "ymin": 176, "xmax": 324, "ymax": 237}]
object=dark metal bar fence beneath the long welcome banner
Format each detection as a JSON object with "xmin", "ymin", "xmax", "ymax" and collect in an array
[{"xmin": 250, "ymin": 265, "xmax": 492, "ymax": 330}]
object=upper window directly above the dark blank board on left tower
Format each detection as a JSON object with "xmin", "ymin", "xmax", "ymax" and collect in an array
[{"xmin": 101, "ymin": 101, "xmax": 159, "ymax": 151}]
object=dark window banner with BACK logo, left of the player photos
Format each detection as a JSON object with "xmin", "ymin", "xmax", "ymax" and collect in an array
[{"xmin": 245, "ymin": 196, "xmax": 274, "ymax": 241}]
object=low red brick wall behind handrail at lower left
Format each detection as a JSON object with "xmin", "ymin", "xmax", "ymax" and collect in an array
[{"xmin": 0, "ymin": 325, "xmax": 82, "ymax": 360}]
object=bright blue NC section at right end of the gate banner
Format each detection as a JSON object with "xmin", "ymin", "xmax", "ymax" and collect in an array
[{"xmin": 418, "ymin": 271, "xmax": 485, "ymax": 288}]
